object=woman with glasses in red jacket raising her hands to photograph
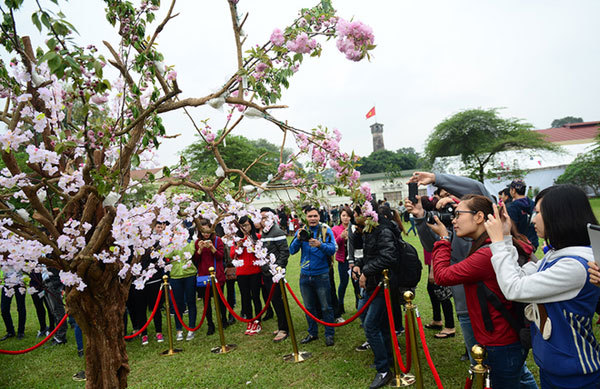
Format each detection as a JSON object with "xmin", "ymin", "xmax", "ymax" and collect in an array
[{"xmin": 429, "ymin": 195, "xmax": 537, "ymax": 389}]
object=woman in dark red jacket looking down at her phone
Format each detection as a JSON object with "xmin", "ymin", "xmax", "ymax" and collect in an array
[{"xmin": 192, "ymin": 219, "xmax": 227, "ymax": 335}]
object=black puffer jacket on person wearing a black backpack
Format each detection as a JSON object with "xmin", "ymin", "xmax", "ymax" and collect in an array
[{"xmin": 355, "ymin": 218, "xmax": 400, "ymax": 293}]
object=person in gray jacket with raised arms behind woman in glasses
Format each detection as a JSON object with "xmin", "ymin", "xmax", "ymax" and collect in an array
[{"xmin": 405, "ymin": 172, "xmax": 492, "ymax": 364}]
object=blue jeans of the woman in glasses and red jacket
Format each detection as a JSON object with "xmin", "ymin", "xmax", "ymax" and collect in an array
[{"xmin": 485, "ymin": 342, "xmax": 537, "ymax": 389}]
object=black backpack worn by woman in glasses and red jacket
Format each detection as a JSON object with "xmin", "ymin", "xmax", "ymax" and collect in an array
[{"xmin": 477, "ymin": 245, "xmax": 537, "ymax": 351}]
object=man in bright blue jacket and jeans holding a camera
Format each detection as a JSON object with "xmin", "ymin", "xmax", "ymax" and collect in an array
[{"xmin": 290, "ymin": 206, "xmax": 336, "ymax": 346}]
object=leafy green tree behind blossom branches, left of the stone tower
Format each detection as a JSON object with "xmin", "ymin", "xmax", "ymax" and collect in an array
[{"xmin": 181, "ymin": 135, "xmax": 292, "ymax": 181}]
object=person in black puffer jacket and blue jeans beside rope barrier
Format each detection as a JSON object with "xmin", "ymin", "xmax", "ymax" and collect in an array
[{"xmin": 352, "ymin": 205, "xmax": 400, "ymax": 388}]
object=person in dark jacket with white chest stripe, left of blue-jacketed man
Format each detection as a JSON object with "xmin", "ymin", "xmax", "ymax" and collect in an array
[{"xmin": 260, "ymin": 207, "xmax": 290, "ymax": 342}]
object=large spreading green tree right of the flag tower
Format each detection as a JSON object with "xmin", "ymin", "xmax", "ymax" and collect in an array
[{"xmin": 425, "ymin": 108, "xmax": 560, "ymax": 182}]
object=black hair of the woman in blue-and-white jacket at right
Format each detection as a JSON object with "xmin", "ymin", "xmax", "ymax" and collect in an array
[{"xmin": 536, "ymin": 185, "xmax": 598, "ymax": 250}]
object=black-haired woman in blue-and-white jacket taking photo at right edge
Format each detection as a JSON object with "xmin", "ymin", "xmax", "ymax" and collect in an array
[{"xmin": 485, "ymin": 185, "xmax": 600, "ymax": 389}]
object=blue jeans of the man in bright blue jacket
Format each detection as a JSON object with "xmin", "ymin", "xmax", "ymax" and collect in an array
[{"xmin": 300, "ymin": 273, "xmax": 334, "ymax": 336}]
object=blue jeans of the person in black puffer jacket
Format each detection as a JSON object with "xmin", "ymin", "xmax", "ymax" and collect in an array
[{"xmin": 363, "ymin": 290, "xmax": 394, "ymax": 373}]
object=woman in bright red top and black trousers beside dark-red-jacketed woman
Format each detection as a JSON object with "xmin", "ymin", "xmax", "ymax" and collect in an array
[{"xmin": 231, "ymin": 216, "xmax": 262, "ymax": 335}]
